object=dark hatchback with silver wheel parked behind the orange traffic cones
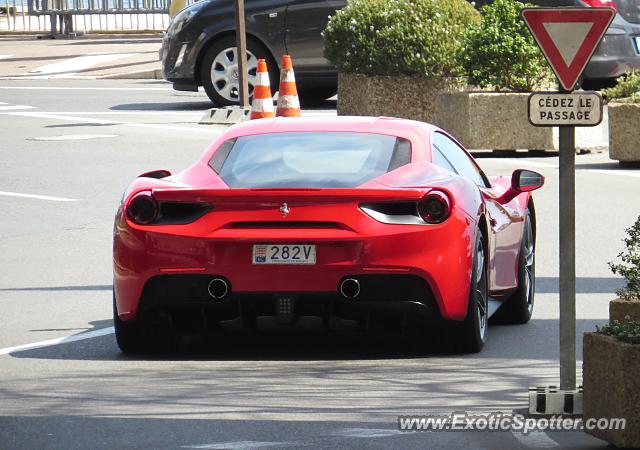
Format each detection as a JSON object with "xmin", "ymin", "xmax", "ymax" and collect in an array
[{"xmin": 160, "ymin": 0, "xmax": 346, "ymax": 106}]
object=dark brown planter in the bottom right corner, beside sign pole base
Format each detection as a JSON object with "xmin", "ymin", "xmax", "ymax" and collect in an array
[{"xmin": 583, "ymin": 333, "xmax": 640, "ymax": 448}]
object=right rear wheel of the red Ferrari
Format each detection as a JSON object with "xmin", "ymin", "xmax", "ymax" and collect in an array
[{"xmin": 451, "ymin": 230, "xmax": 489, "ymax": 353}]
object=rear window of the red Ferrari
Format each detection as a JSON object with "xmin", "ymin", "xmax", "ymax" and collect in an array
[{"xmin": 210, "ymin": 132, "xmax": 411, "ymax": 188}]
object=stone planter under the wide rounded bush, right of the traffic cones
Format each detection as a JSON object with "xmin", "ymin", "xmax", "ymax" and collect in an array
[{"xmin": 337, "ymin": 72, "xmax": 460, "ymax": 123}]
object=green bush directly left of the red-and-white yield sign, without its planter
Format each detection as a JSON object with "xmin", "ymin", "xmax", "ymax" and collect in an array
[{"xmin": 461, "ymin": 0, "xmax": 552, "ymax": 92}]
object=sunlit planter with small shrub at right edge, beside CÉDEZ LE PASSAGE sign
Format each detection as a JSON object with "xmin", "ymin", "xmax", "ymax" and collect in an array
[{"xmin": 602, "ymin": 71, "xmax": 640, "ymax": 163}]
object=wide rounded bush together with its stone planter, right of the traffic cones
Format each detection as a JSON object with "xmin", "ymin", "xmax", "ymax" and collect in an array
[{"xmin": 323, "ymin": 0, "xmax": 479, "ymax": 121}]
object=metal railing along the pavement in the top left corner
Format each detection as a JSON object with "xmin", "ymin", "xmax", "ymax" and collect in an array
[{"xmin": 0, "ymin": 0, "xmax": 171, "ymax": 34}]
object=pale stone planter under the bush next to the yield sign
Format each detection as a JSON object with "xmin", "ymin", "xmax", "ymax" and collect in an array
[{"xmin": 436, "ymin": 92, "xmax": 556, "ymax": 150}]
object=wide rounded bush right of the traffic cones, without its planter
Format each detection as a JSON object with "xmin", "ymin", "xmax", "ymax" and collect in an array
[{"xmin": 323, "ymin": 0, "xmax": 479, "ymax": 78}]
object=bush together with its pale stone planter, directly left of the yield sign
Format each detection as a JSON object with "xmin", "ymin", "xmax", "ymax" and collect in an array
[{"xmin": 437, "ymin": 0, "xmax": 554, "ymax": 150}]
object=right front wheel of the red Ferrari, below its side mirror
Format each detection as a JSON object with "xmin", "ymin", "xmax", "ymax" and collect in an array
[{"xmin": 496, "ymin": 210, "xmax": 536, "ymax": 324}]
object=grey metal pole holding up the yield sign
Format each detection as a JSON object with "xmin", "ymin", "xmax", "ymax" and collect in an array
[{"xmin": 559, "ymin": 127, "xmax": 576, "ymax": 389}]
